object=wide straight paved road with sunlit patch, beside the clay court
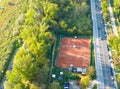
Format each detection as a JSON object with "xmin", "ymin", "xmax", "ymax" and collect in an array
[{"xmin": 91, "ymin": 0, "xmax": 117, "ymax": 89}]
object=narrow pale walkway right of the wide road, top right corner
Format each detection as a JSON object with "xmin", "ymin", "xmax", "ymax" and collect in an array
[{"xmin": 108, "ymin": 0, "xmax": 118, "ymax": 37}]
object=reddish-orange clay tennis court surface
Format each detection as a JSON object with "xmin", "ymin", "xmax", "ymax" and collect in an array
[{"xmin": 56, "ymin": 37, "xmax": 90, "ymax": 68}]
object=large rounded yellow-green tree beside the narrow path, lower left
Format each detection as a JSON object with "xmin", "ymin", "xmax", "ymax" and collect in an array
[{"xmin": 13, "ymin": 49, "xmax": 37, "ymax": 81}]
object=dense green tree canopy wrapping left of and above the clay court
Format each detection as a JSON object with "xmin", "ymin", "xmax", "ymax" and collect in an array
[{"xmin": 0, "ymin": 0, "xmax": 92, "ymax": 89}]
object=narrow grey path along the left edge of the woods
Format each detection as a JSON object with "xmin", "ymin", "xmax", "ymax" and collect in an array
[{"xmin": 0, "ymin": 49, "xmax": 19, "ymax": 89}]
